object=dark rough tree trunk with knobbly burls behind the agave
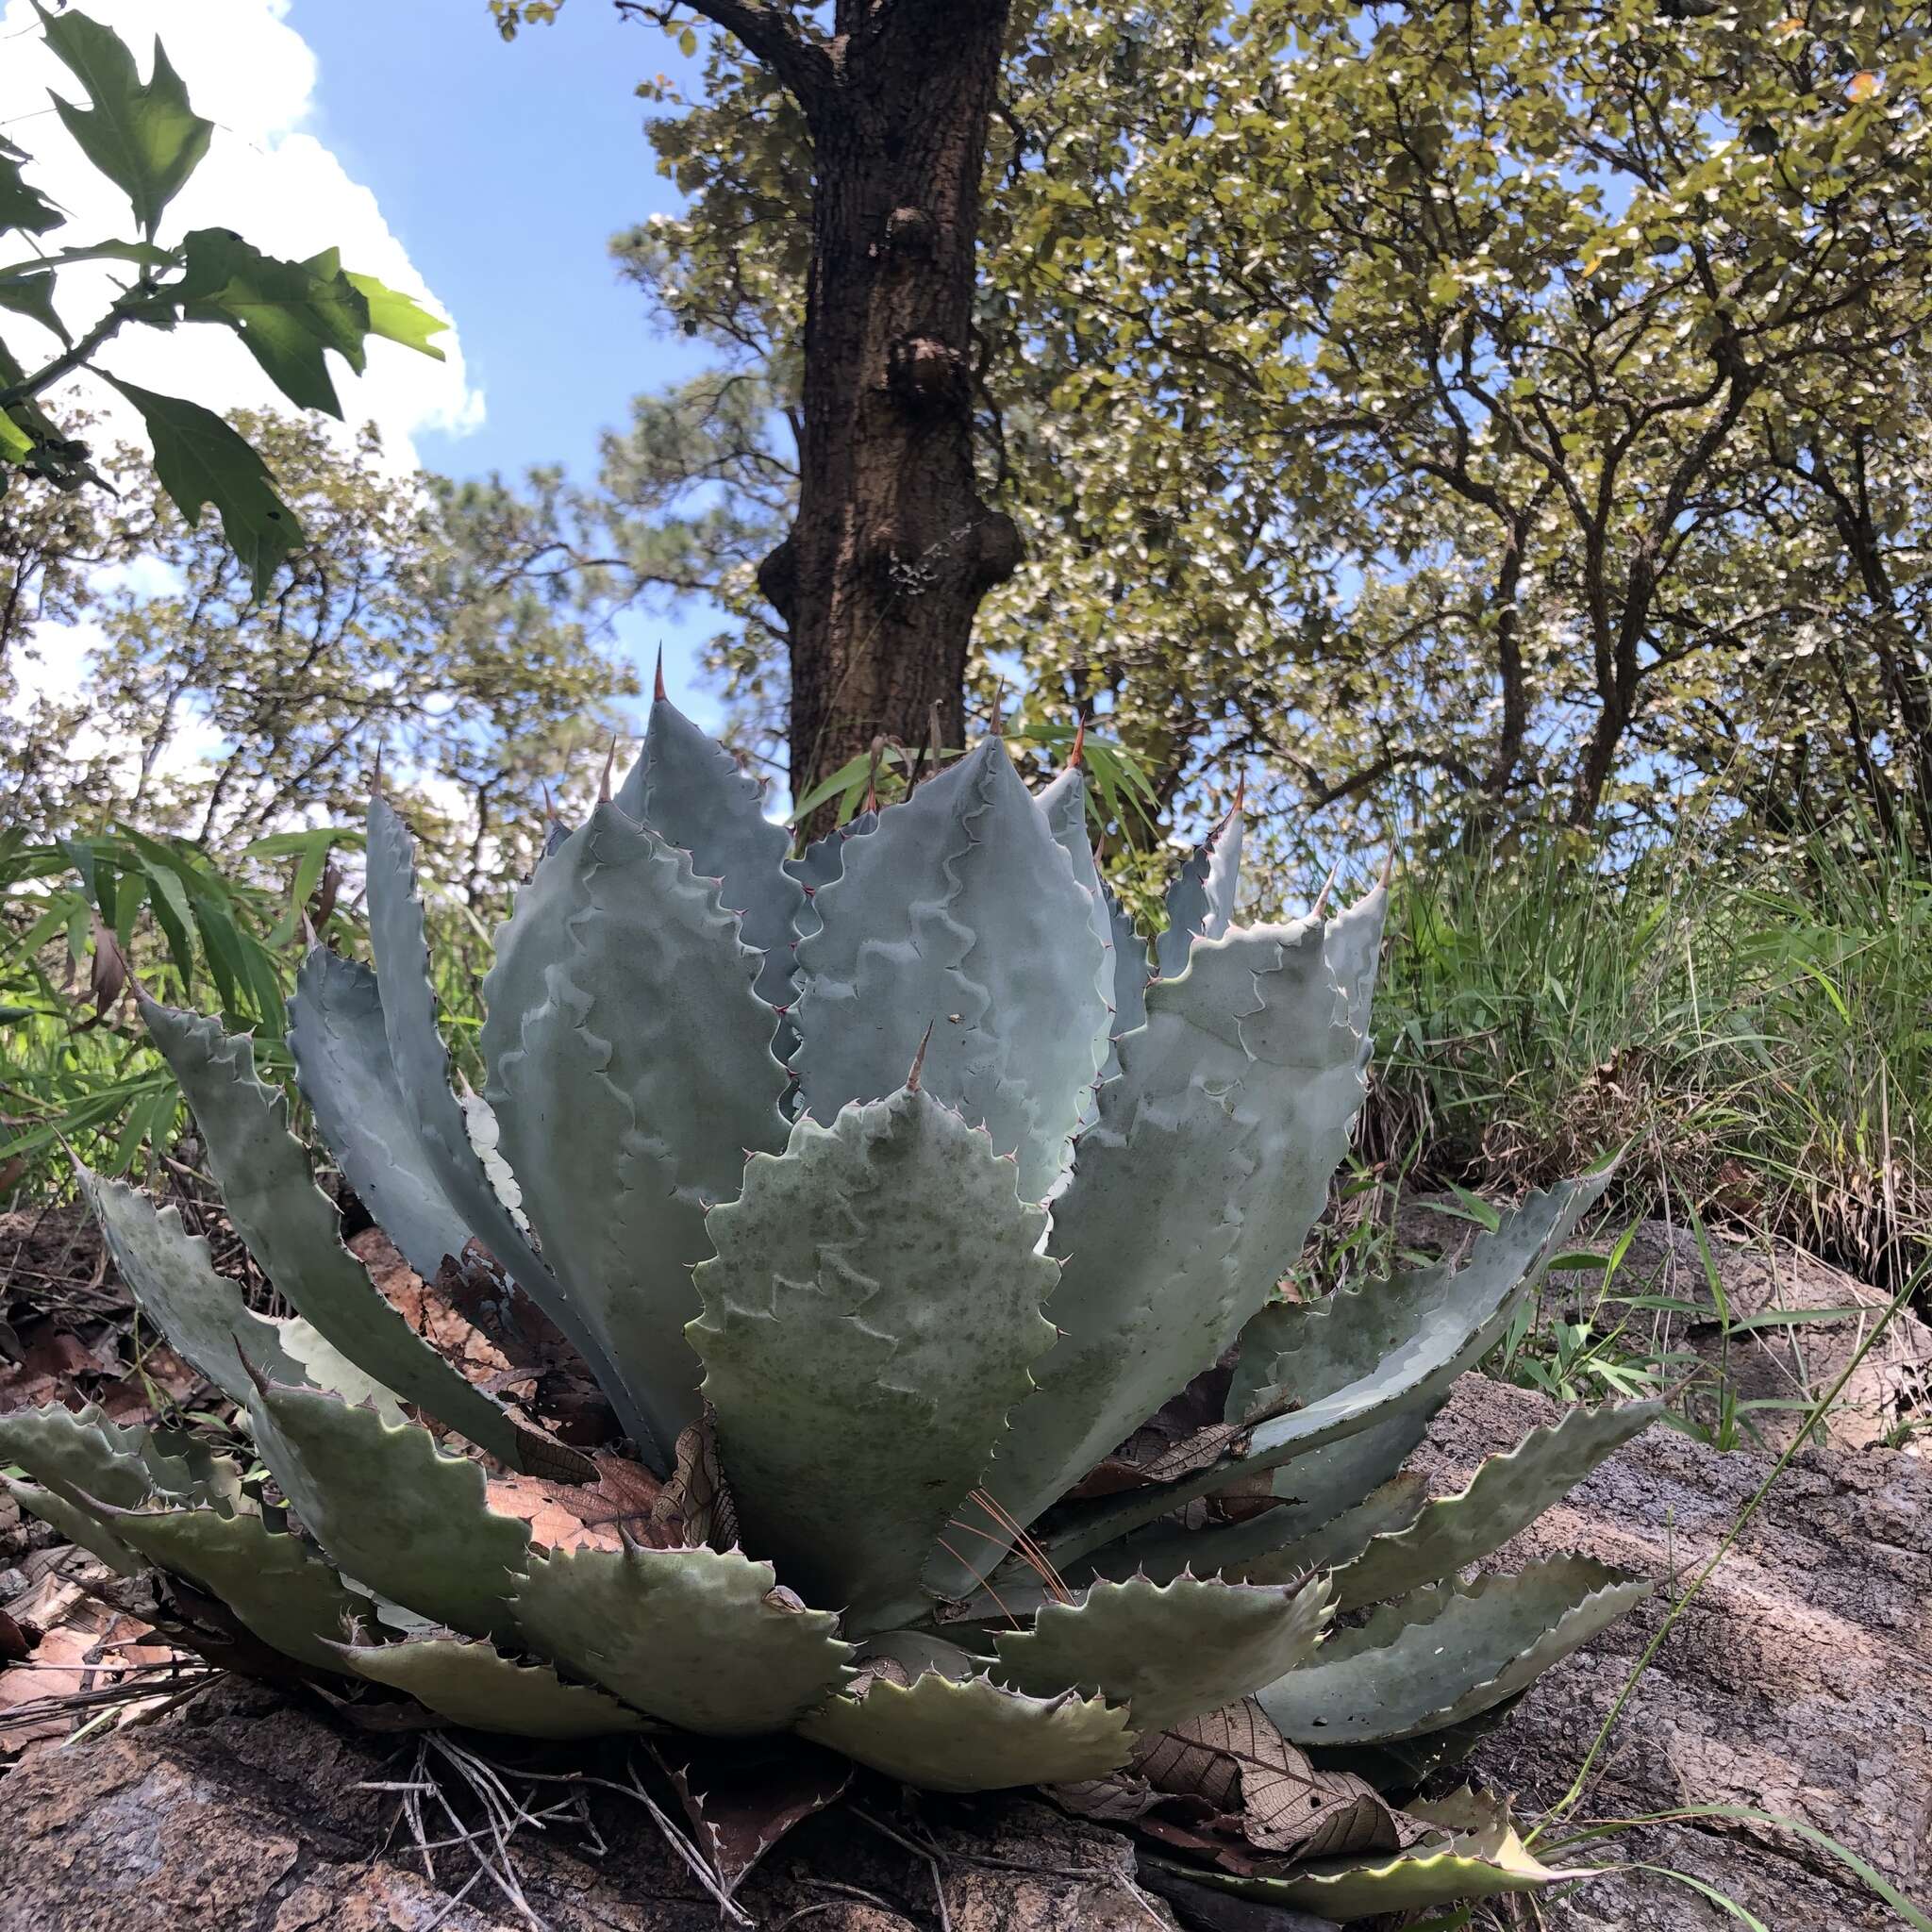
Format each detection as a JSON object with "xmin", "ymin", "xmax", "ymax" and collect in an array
[{"xmin": 693, "ymin": 0, "xmax": 1020, "ymax": 819}]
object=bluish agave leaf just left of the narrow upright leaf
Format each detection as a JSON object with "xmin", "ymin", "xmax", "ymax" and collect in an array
[{"xmin": 288, "ymin": 944, "xmax": 470, "ymax": 1281}]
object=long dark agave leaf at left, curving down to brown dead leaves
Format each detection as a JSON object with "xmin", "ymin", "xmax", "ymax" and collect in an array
[{"xmin": 142, "ymin": 1001, "xmax": 559, "ymax": 1474}]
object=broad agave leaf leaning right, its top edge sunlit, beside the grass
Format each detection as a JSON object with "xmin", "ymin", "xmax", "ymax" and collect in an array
[{"xmin": 961, "ymin": 908, "xmax": 1362, "ymax": 1568}]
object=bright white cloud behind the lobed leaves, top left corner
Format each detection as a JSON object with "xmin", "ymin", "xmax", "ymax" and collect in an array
[{"xmin": 0, "ymin": 0, "xmax": 483, "ymax": 470}]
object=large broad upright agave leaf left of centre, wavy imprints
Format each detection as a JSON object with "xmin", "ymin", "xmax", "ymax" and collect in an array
[{"xmin": 483, "ymin": 806, "xmax": 787, "ymax": 1445}]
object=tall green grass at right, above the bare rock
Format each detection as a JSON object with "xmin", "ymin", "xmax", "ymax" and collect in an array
[{"xmin": 1362, "ymin": 831, "xmax": 1932, "ymax": 1285}]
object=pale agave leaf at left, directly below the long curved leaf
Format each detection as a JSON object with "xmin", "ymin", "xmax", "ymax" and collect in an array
[{"xmin": 81, "ymin": 1169, "xmax": 402, "ymax": 1422}]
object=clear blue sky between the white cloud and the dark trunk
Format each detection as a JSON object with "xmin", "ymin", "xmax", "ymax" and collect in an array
[{"xmin": 288, "ymin": 0, "xmax": 717, "ymax": 723}]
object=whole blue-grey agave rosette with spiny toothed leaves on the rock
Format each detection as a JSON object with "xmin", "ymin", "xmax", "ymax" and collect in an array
[{"xmin": 0, "ymin": 699, "xmax": 1652, "ymax": 1913}]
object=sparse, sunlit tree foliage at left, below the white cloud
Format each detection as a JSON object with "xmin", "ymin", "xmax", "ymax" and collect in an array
[{"xmin": 0, "ymin": 415, "xmax": 638, "ymax": 904}]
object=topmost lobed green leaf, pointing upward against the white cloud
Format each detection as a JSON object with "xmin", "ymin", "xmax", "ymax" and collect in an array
[{"xmin": 35, "ymin": 0, "xmax": 214, "ymax": 236}]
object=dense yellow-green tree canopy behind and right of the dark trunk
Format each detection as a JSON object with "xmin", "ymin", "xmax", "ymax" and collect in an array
[{"xmin": 556, "ymin": 0, "xmax": 1932, "ymax": 869}]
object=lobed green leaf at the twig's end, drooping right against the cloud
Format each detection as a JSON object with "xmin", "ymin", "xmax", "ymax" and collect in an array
[{"xmin": 175, "ymin": 228, "xmax": 369, "ymax": 417}]
